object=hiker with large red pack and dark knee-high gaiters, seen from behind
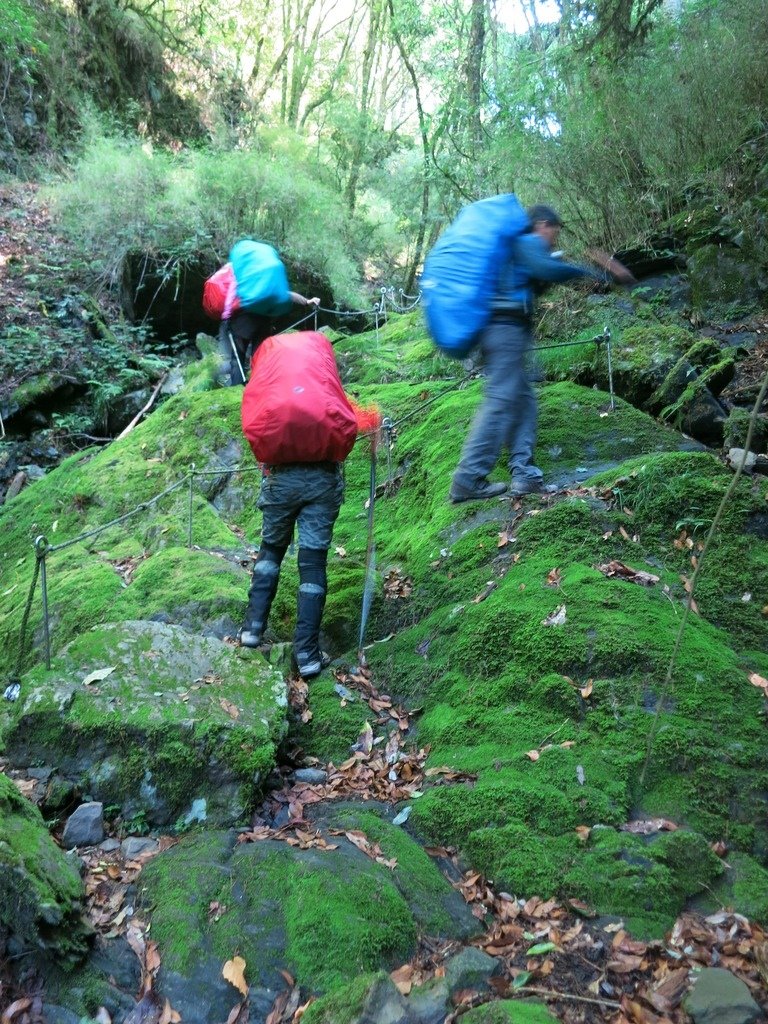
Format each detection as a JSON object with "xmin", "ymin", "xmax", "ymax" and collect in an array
[{"xmin": 240, "ymin": 331, "xmax": 381, "ymax": 679}]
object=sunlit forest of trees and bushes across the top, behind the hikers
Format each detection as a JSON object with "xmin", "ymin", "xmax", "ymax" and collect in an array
[{"xmin": 0, "ymin": 0, "xmax": 768, "ymax": 314}]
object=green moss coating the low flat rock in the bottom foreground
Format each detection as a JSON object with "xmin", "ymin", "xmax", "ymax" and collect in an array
[{"xmin": 142, "ymin": 834, "xmax": 416, "ymax": 991}]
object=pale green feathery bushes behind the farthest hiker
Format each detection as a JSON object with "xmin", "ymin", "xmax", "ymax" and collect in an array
[{"xmin": 49, "ymin": 131, "xmax": 402, "ymax": 306}]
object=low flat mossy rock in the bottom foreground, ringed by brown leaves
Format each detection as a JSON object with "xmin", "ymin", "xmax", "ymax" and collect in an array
[{"xmin": 135, "ymin": 806, "xmax": 478, "ymax": 1022}]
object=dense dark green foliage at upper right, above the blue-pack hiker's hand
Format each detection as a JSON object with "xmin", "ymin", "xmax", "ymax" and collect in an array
[{"xmin": 504, "ymin": 0, "xmax": 766, "ymax": 256}]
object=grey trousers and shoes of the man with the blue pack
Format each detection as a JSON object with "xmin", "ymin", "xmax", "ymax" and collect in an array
[{"xmin": 454, "ymin": 317, "xmax": 542, "ymax": 489}]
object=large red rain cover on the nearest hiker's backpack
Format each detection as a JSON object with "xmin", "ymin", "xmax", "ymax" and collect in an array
[{"xmin": 241, "ymin": 331, "xmax": 357, "ymax": 466}]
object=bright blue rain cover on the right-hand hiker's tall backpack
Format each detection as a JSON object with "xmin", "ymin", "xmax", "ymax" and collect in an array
[{"xmin": 421, "ymin": 193, "xmax": 528, "ymax": 359}]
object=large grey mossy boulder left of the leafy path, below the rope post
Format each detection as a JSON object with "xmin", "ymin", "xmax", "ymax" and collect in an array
[{"xmin": 5, "ymin": 622, "xmax": 287, "ymax": 825}]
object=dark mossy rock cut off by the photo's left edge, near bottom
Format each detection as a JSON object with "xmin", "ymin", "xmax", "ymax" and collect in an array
[{"xmin": 0, "ymin": 774, "xmax": 89, "ymax": 967}]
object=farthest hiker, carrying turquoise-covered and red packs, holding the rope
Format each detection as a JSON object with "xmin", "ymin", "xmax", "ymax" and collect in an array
[{"xmin": 203, "ymin": 239, "xmax": 319, "ymax": 385}]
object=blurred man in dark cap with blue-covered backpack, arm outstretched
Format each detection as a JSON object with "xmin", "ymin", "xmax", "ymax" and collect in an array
[{"xmin": 422, "ymin": 195, "xmax": 634, "ymax": 502}]
